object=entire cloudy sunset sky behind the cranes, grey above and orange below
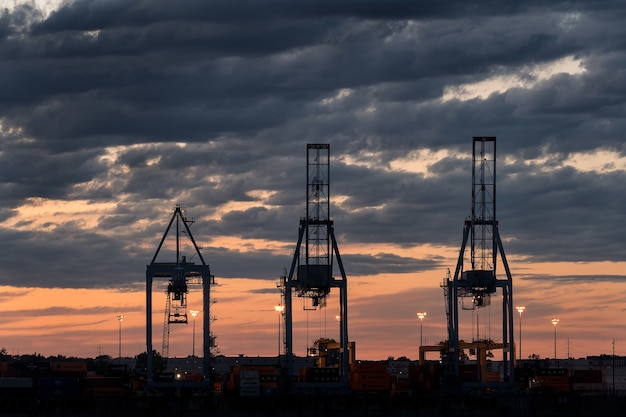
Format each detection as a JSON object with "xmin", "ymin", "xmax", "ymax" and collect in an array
[{"xmin": 0, "ymin": 0, "xmax": 626, "ymax": 359}]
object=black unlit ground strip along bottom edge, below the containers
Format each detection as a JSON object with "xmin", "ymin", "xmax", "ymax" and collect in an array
[{"xmin": 0, "ymin": 393, "xmax": 626, "ymax": 417}]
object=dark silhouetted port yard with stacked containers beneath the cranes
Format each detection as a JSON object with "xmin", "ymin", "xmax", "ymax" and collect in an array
[{"xmin": 0, "ymin": 356, "xmax": 626, "ymax": 417}]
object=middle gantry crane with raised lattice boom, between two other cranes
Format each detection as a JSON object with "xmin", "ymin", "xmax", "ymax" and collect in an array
[{"xmin": 282, "ymin": 144, "xmax": 350, "ymax": 386}]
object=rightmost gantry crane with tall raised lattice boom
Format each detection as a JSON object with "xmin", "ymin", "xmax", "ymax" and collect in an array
[{"xmin": 443, "ymin": 136, "xmax": 515, "ymax": 384}]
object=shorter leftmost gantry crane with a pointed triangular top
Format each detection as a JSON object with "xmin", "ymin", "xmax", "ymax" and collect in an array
[{"xmin": 146, "ymin": 205, "xmax": 214, "ymax": 386}]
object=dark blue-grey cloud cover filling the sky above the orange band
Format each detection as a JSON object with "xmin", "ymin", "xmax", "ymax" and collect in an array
[{"xmin": 0, "ymin": 0, "xmax": 626, "ymax": 286}]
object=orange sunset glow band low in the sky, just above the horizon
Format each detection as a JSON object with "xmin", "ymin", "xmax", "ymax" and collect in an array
[{"xmin": 0, "ymin": 254, "xmax": 626, "ymax": 359}]
